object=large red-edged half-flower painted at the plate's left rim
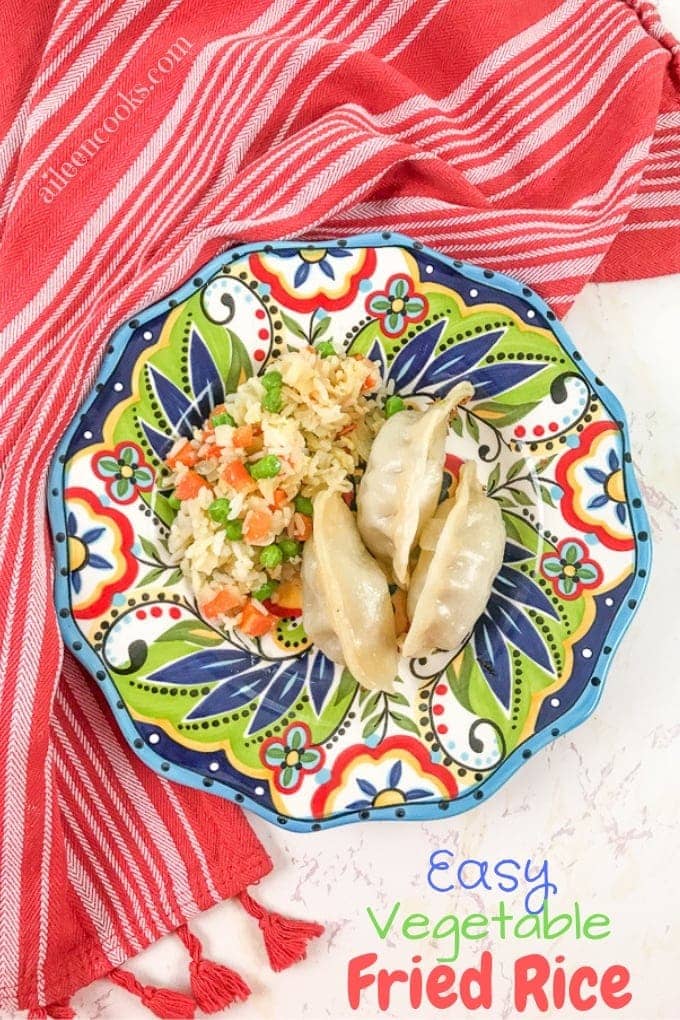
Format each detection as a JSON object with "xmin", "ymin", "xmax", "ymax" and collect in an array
[{"xmin": 64, "ymin": 488, "xmax": 139, "ymax": 619}]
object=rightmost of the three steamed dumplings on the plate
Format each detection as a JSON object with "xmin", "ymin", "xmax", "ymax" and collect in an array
[{"xmin": 402, "ymin": 461, "xmax": 506, "ymax": 659}]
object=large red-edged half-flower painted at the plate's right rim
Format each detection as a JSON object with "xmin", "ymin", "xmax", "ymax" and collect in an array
[{"xmin": 555, "ymin": 421, "xmax": 634, "ymax": 552}]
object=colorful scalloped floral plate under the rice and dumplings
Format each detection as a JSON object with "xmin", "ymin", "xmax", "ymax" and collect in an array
[{"xmin": 50, "ymin": 234, "xmax": 650, "ymax": 831}]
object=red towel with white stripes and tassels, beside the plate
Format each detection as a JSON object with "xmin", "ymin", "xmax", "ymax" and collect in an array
[{"xmin": 0, "ymin": 0, "xmax": 680, "ymax": 1015}]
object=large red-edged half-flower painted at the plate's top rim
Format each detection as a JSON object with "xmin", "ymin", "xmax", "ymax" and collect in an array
[{"xmin": 249, "ymin": 246, "xmax": 375, "ymax": 312}]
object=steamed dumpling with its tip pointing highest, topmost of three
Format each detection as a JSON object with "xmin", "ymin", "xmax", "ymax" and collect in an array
[{"xmin": 357, "ymin": 383, "xmax": 474, "ymax": 588}]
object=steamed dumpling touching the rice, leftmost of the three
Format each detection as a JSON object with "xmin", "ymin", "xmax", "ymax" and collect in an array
[{"xmin": 302, "ymin": 492, "xmax": 398, "ymax": 691}]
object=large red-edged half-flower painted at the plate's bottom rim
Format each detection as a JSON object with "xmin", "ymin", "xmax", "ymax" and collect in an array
[{"xmin": 312, "ymin": 736, "xmax": 458, "ymax": 818}]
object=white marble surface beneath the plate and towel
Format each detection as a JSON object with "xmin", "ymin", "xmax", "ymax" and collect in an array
[{"xmin": 57, "ymin": 276, "xmax": 680, "ymax": 1020}]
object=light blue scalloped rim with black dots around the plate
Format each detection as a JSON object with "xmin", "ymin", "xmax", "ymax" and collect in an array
[{"xmin": 47, "ymin": 231, "xmax": 651, "ymax": 832}]
